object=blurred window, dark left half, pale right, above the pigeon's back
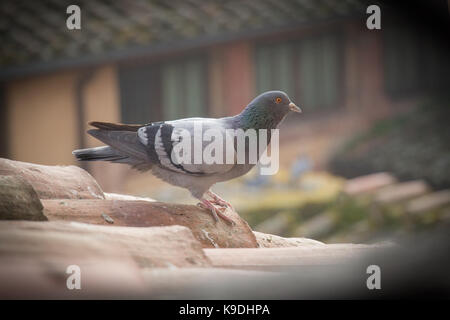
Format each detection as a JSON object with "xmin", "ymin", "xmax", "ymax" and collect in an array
[{"xmin": 119, "ymin": 57, "xmax": 208, "ymax": 123}]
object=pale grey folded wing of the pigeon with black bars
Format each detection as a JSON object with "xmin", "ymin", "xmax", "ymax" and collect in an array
[{"xmin": 137, "ymin": 118, "xmax": 236, "ymax": 176}]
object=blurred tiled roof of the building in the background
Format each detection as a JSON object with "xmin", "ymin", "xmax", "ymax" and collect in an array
[{"xmin": 0, "ymin": 0, "xmax": 364, "ymax": 77}]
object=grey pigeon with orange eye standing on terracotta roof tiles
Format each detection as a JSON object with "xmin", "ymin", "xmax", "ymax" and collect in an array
[{"xmin": 72, "ymin": 91, "xmax": 301, "ymax": 225}]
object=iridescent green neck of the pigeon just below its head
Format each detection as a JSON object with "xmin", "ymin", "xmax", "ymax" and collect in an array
[{"xmin": 235, "ymin": 105, "xmax": 287, "ymax": 130}]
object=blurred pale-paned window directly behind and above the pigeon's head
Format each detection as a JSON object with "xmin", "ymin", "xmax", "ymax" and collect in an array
[{"xmin": 256, "ymin": 34, "xmax": 341, "ymax": 109}]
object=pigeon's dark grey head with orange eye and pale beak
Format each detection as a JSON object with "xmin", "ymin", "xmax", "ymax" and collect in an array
[{"xmin": 241, "ymin": 91, "xmax": 302, "ymax": 128}]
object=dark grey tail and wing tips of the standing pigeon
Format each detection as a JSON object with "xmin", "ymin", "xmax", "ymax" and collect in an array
[{"xmin": 72, "ymin": 123, "xmax": 152, "ymax": 171}]
